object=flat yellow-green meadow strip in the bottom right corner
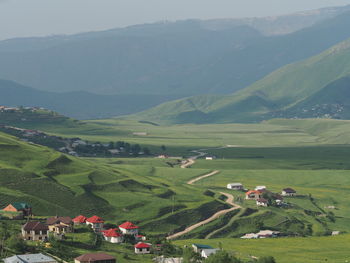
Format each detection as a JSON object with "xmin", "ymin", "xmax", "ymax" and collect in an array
[{"xmin": 175, "ymin": 235, "xmax": 350, "ymax": 263}]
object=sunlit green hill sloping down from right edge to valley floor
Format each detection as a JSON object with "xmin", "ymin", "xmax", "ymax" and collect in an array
[{"xmin": 131, "ymin": 40, "xmax": 350, "ymax": 123}]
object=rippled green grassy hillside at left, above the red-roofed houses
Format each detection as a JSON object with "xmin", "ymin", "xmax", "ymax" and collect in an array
[{"xmin": 0, "ymin": 133, "xmax": 230, "ymax": 236}]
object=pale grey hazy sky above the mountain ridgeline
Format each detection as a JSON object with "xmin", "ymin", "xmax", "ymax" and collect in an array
[{"xmin": 0, "ymin": 0, "xmax": 350, "ymax": 39}]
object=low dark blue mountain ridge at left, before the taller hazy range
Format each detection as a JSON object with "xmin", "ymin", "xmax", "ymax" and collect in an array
[{"xmin": 0, "ymin": 79, "xmax": 178, "ymax": 119}]
